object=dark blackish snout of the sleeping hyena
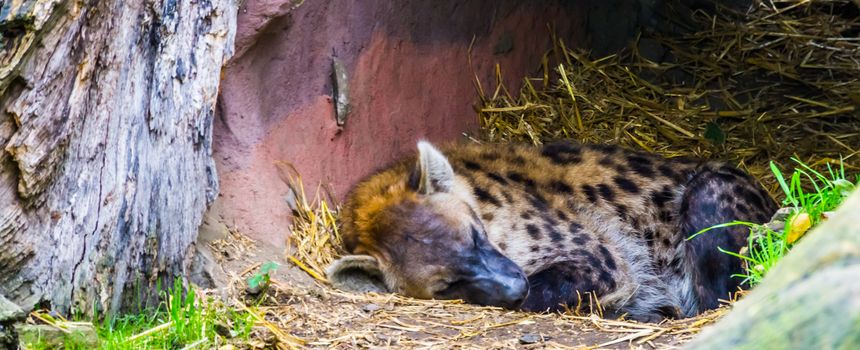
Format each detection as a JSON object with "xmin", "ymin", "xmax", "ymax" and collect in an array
[{"xmin": 436, "ymin": 246, "xmax": 529, "ymax": 309}]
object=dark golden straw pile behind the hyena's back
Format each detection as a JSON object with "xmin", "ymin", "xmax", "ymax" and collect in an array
[{"xmin": 478, "ymin": 0, "xmax": 860, "ymax": 194}]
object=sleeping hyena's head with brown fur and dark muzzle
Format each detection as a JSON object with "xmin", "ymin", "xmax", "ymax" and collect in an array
[{"xmin": 328, "ymin": 142, "xmax": 528, "ymax": 308}]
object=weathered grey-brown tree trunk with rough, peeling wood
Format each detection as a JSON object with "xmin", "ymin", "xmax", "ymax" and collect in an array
[{"xmin": 0, "ymin": 0, "xmax": 236, "ymax": 313}]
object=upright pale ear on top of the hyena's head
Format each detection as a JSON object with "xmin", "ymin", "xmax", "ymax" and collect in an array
[{"xmin": 409, "ymin": 141, "xmax": 454, "ymax": 195}]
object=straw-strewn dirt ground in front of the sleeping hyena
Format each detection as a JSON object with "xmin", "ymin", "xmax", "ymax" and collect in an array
[{"xmin": 205, "ymin": 231, "xmax": 727, "ymax": 349}]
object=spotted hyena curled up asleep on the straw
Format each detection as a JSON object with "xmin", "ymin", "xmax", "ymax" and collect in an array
[{"xmin": 329, "ymin": 142, "xmax": 776, "ymax": 321}]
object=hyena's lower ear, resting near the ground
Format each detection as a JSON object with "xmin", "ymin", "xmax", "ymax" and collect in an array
[{"xmin": 326, "ymin": 255, "xmax": 389, "ymax": 293}]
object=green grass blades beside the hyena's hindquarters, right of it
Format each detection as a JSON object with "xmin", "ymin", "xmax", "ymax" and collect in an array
[{"xmin": 688, "ymin": 158, "xmax": 860, "ymax": 286}]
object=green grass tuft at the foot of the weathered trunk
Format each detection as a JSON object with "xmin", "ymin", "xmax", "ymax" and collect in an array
[{"xmin": 28, "ymin": 279, "xmax": 255, "ymax": 349}]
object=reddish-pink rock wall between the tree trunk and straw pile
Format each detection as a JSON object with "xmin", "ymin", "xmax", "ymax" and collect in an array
[{"xmin": 210, "ymin": 0, "xmax": 585, "ymax": 245}]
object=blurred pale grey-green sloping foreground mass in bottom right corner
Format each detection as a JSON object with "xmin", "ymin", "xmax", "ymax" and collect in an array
[{"xmin": 687, "ymin": 191, "xmax": 860, "ymax": 349}]
